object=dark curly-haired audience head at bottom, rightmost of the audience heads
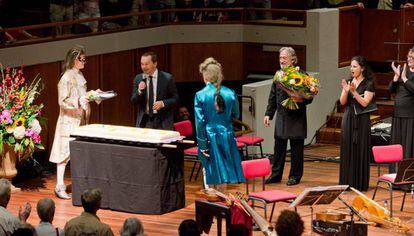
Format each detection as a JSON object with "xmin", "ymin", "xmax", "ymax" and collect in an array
[{"xmin": 276, "ymin": 210, "xmax": 305, "ymax": 236}]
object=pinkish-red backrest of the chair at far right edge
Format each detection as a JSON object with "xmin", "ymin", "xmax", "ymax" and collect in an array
[{"xmin": 372, "ymin": 144, "xmax": 403, "ymax": 163}]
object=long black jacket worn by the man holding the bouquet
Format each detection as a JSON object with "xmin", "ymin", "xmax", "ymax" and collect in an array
[{"xmin": 265, "ymin": 80, "xmax": 313, "ymax": 139}]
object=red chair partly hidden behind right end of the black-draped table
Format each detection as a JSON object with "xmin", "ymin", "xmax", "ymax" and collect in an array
[{"xmin": 174, "ymin": 120, "xmax": 201, "ymax": 181}]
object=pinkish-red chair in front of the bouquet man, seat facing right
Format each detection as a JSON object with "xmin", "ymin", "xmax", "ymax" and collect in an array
[{"xmin": 242, "ymin": 158, "xmax": 296, "ymax": 222}]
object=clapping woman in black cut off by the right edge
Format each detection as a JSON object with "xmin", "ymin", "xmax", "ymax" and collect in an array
[{"xmin": 389, "ymin": 48, "xmax": 414, "ymax": 172}]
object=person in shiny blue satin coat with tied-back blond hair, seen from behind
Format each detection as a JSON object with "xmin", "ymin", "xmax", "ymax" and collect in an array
[{"xmin": 194, "ymin": 57, "xmax": 246, "ymax": 191}]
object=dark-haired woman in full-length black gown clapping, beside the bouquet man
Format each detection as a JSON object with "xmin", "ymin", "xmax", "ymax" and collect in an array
[{"xmin": 339, "ymin": 56, "xmax": 375, "ymax": 191}]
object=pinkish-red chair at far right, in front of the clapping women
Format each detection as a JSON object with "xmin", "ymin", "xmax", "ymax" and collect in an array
[{"xmin": 372, "ymin": 144, "xmax": 414, "ymax": 217}]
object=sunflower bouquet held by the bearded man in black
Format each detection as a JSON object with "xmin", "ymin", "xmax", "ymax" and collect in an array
[{"xmin": 274, "ymin": 67, "xmax": 320, "ymax": 110}]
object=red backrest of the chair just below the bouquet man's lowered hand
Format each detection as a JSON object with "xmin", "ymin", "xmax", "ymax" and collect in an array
[{"xmin": 242, "ymin": 158, "xmax": 271, "ymax": 179}]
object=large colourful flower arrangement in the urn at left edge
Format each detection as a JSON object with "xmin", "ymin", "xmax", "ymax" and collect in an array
[{"xmin": 0, "ymin": 64, "xmax": 44, "ymax": 158}]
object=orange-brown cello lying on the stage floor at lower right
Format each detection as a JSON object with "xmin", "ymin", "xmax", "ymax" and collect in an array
[{"xmin": 351, "ymin": 187, "xmax": 410, "ymax": 233}]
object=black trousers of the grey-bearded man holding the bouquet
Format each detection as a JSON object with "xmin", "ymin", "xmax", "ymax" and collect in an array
[{"xmin": 271, "ymin": 138, "xmax": 305, "ymax": 181}]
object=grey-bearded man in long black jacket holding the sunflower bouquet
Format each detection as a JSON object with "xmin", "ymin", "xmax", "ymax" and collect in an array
[{"xmin": 263, "ymin": 47, "xmax": 312, "ymax": 185}]
